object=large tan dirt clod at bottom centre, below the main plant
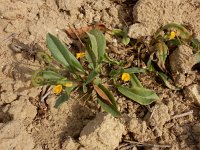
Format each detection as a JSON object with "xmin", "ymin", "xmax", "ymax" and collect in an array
[{"xmin": 79, "ymin": 113, "xmax": 125, "ymax": 150}]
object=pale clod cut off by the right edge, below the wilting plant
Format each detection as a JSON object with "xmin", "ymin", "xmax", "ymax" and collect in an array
[{"xmin": 184, "ymin": 84, "xmax": 200, "ymax": 106}]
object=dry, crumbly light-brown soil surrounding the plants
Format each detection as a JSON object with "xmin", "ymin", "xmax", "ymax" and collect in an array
[{"xmin": 0, "ymin": 0, "xmax": 200, "ymax": 150}]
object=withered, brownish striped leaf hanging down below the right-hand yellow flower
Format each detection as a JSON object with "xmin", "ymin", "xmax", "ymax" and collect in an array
[{"xmin": 155, "ymin": 41, "xmax": 169, "ymax": 71}]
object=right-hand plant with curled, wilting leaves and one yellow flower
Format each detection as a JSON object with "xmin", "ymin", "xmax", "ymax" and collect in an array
[{"xmin": 147, "ymin": 23, "xmax": 200, "ymax": 90}]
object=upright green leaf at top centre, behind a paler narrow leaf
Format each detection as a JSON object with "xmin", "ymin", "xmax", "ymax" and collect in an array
[{"xmin": 90, "ymin": 29, "xmax": 106, "ymax": 63}]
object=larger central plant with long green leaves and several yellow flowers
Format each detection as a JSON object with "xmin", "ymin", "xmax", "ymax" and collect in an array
[{"xmin": 32, "ymin": 29, "xmax": 159, "ymax": 117}]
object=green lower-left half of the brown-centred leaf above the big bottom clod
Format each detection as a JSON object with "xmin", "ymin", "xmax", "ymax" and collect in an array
[{"xmin": 97, "ymin": 98, "xmax": 120, "ymax": 117}]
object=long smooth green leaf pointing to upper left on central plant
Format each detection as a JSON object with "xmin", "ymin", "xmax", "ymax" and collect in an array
[{"xmin": 46, "ymin": 33, "xmax": 85, "ymax": 72}]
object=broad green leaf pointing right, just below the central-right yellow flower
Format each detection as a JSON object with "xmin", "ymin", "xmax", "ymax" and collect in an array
[{"xmin": 117, "ymin": 85, "xmax": 159, "ymax": 105}]
